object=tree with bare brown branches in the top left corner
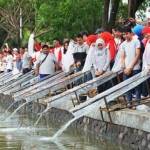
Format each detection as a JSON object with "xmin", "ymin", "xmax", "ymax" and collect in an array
[{"xmin": 0, "ymin": 0, "xmax": 34, "ymax": 47}]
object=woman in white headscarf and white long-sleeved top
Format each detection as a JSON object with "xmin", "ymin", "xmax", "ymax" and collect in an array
[{"xmin": 82, "ymin": 39, "xmax": 110, "ymax": 76}]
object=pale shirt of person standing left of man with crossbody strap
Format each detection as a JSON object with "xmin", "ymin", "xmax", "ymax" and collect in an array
[{"xmin": 22, "ymin": 52, "xmax": 31, "ymax": 69}]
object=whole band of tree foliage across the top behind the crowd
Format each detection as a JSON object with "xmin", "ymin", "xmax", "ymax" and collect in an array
[{"xmin": 0, "ymin": 0, "xmax": 148, "ymax": 47}]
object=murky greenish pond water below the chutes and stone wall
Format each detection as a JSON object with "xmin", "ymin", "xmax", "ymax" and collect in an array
[{"xmin": 0, "ymin": 109, "xmax": 128, "ymax": 150}]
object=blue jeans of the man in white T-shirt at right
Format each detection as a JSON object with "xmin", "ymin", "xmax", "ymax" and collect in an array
[{"xmin": 123, "ymin": 70, "xmax": 141, "ymax": 102}]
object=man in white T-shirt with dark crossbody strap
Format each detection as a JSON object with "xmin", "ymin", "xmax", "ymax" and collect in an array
[{"xmin": 35, "ymin": 45, "xmax": 57, "ymax": 79}]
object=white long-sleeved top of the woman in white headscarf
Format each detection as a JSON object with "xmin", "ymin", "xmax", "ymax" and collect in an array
[{"xmin": 82, "ymin": 46, "xmax": 110, "ymax": 72}]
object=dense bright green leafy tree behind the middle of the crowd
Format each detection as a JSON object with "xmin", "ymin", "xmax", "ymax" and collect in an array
[{"xmin": 36, "ymin": 0, "xmax": 102, "ymax": 41}]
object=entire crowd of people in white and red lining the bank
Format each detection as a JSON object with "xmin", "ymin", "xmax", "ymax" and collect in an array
[{"xmin": 0, "ymin": 18, "xmax": 150, "ymax": 106}]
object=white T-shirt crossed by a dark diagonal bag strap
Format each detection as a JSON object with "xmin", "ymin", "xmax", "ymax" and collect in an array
[{"xmin": 36, "ymin": 53, "xmax": 56, "ymax": 75}]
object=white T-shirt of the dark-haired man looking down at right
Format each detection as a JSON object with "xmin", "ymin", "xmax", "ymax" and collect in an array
[{"xmin": 122, "ymin": 39, "xmax": 141, "ymax": 70}]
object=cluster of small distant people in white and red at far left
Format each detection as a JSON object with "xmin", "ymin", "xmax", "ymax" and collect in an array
[{"xmin": 0, "ymin": 44, "xmax": 32, "ymax": 74}]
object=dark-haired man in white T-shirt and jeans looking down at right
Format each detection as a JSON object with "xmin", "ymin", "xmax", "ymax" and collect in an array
[{"xmin": 121, "ymin": 28, "xmax": 141, "ymax": 108}]
